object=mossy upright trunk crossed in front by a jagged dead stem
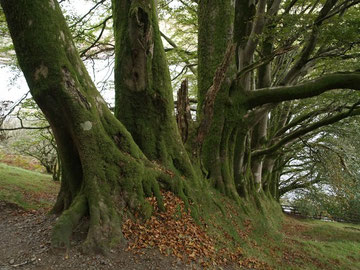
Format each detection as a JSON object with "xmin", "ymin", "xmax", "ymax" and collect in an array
[{"xmin": 198, "ymin": 1, "xmax": 243, "ymax": 198}]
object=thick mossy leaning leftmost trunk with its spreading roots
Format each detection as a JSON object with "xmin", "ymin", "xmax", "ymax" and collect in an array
[{"xmin": 1, "ymin": 0, "xmax": 191, "ymax": 251}]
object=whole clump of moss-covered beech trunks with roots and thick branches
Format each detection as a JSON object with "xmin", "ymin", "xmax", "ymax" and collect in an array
[{"xmin": 0, "ymin": 0, "xmax": 360, "ymax": 253}]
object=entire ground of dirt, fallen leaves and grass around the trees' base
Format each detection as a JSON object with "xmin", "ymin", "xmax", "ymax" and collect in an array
[{"xmin": 0, "ymin": 159, "xmax": 360, "ymax": 270}]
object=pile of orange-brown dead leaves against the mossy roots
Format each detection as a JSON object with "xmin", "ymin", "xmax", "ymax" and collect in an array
[{"xmin": 122, "ymin": 192, "xmax": 272, "ymax": 269}]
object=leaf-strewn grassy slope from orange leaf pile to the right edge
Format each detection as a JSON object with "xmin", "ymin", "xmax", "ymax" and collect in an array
[{"xmin": 198, "ymin": 191, "xmax": 360, "ymax": 270}]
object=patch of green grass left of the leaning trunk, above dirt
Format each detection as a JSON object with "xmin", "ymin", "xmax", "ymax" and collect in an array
[{"xmin": 0, "ymin": 163, "xmax": 59, "ymax": 210}]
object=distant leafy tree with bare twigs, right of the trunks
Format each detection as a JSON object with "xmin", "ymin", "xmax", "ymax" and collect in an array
[{"xmin": 283, "ymin": 119, "xmax": 360, "ymax": 221}]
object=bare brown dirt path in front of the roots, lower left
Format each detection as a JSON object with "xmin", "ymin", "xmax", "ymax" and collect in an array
[{"xmin": 0, "ymin": 202, "xmax": 197, "ymax": 270}]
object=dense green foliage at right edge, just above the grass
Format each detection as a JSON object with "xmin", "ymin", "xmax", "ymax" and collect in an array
[{"xmin": 293, "ymin": 119, "xmax": 360, "ymax": 221}]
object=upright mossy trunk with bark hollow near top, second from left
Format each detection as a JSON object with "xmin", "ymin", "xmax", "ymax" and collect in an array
[{"xmin": 113, "ymin": 0, "xmax": 195, "ymax": 178}]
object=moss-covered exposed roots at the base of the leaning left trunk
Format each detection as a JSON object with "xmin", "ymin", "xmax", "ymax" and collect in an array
[{"xmin": 52, "ymin": 160, "xmax": 197, "ymax": 255}]
